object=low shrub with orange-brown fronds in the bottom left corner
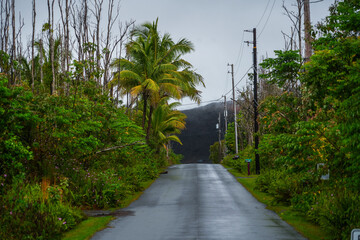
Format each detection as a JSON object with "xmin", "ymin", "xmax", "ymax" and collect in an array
[{"xmin": 0, "ymin": 181, "xmax": 83, "ymax": 239}]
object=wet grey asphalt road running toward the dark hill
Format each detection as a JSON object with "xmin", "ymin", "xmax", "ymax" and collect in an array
[{"xmin": 92, "ymin": 164, "xmax": 305, "ymax": 240}]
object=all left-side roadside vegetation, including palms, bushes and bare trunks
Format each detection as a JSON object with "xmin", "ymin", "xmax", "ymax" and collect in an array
[{"xmin": 0, "ymin": 1, "xmax": 203, "ymax": 239}]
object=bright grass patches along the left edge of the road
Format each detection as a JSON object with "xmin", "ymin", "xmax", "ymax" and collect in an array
[{"xmin": 62, "ymin": 179, "xmax": 155, "ymax": 240}]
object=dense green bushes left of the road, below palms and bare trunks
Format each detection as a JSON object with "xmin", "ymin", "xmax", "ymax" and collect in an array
[{"xmin": 0, "ymin": 75, "xmax": 166, "ymax": 239}]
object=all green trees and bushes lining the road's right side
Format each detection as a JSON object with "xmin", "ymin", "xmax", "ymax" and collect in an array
[{"xmin": 211, "ymin": 0, "xmax": 360, "ymax": 239}]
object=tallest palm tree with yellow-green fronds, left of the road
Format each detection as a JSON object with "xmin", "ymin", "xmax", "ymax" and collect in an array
[{"xmin": 110, "ymin": 20, "xmax": 204, "ymax": 139}]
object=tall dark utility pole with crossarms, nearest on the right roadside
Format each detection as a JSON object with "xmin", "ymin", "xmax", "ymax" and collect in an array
[{"xmin": 246, "ymin": 28, "xmax": 260, "ymax": 174}]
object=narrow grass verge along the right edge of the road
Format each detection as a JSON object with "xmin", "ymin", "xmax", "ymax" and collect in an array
[{"xmin": 228, "ymin": 165, "xmax": 329, "ymax": 240}]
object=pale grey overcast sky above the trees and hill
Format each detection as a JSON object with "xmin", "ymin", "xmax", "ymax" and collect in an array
[{"xmin": 16, "ymin": 0, "xmax": 334, "ymax": 109}]
